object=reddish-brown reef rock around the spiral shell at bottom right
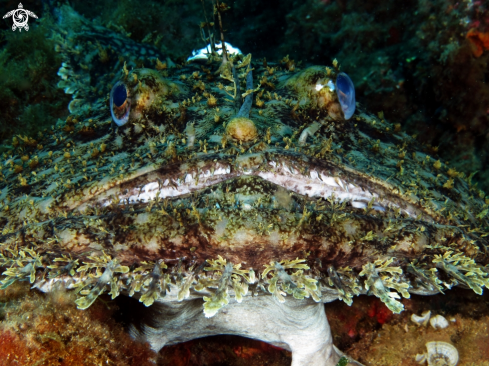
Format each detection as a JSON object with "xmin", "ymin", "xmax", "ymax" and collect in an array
[{"xmin": 336, "ymin": 289, "xmax": 489, "ymax": 366}]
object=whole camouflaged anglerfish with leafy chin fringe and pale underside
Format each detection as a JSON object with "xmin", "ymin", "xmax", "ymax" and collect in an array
[{"xmin": 0, "ymin": 7, "xmax": 489, "ymax": 366}]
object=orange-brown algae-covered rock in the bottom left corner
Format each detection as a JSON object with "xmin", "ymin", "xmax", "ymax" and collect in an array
[{"xmin": 0, "ymin": 283, "xmax": 156, "ymax": 366}]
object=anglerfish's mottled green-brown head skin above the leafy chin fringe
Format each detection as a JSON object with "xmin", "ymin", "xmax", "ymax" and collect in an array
[{"xmin": 0, "ymin": 17, "xmax": 489, "ymax": 312}]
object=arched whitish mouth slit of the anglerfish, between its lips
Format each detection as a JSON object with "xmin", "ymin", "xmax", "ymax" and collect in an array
[{"xmin": 78, "ymin": 153, "xmax": 433, "ymax": 222}]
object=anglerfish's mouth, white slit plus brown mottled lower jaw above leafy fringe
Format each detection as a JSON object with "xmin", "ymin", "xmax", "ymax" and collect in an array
[{"xmin": 61, "ymin": 147, "xmax": 442, "ymax": 270}]
